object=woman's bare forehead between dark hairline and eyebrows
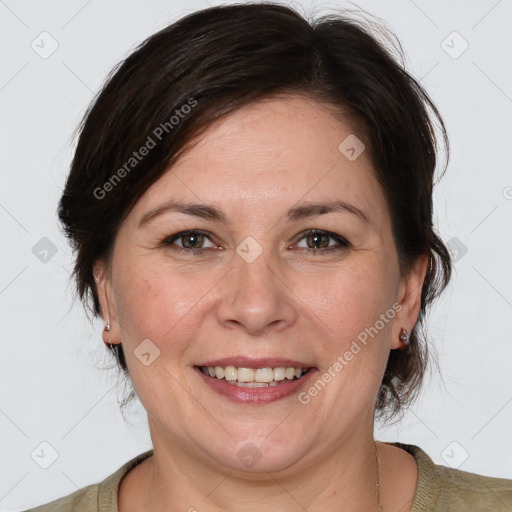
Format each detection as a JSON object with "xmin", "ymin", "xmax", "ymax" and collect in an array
[{"xmin": 130, "ymin": 97, "xmax": 386, "ymax": 226}]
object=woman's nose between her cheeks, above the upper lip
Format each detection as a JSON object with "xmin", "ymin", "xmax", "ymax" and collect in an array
[{"xmin": 217, "ymin": 246, "xmax": 298, "ymax": 336}]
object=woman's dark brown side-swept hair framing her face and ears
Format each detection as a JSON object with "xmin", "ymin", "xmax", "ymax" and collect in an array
[{"xmin": 59, "ymin": 2, "xmax": 451, "ymax": 417}]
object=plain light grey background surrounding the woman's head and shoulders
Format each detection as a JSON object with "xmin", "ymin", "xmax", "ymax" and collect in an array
[{"xmin": 0, "ymin": 0, "xmax": 512, "ymax": 511}]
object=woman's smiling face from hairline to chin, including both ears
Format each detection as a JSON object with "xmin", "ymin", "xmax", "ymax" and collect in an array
[{"xmin": 99, "ymin": 97, "xmax": 426, "ymax": 472}]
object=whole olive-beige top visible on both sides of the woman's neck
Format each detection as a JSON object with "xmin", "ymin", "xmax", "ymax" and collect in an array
[{"xmin": 26, "ymin": 443, "xmax": 512, "ymax": 512}]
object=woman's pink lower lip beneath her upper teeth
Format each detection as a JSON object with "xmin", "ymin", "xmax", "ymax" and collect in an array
[{"xmin": 194, "ymin": 366, "xmax": 316, "ymax": 404}]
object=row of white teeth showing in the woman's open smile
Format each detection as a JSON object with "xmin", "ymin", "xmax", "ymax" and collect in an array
[{"xmin": 197, "ymin": 366, "xmax": 310, "ymax": 388}]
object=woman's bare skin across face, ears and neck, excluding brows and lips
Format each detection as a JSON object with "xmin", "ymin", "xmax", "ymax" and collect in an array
[{"xmin": 95, "ymin": 96, "xmax": 427, "ymax": 512}]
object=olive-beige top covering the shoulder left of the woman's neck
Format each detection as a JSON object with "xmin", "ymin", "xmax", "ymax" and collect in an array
[{"xmin": 25, "ymin": 450, "xmax": 153, "ymax": 512}]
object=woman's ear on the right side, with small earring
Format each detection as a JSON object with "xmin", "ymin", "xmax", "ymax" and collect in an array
[{"xmin": 391, "ymin": 254, "xmax": 430, "ymax": 349}]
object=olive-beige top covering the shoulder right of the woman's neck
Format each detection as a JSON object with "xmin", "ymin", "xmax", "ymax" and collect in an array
[{"xmin": 394, "ymin": 443, "xmax": 512, "ymax": 512}]
